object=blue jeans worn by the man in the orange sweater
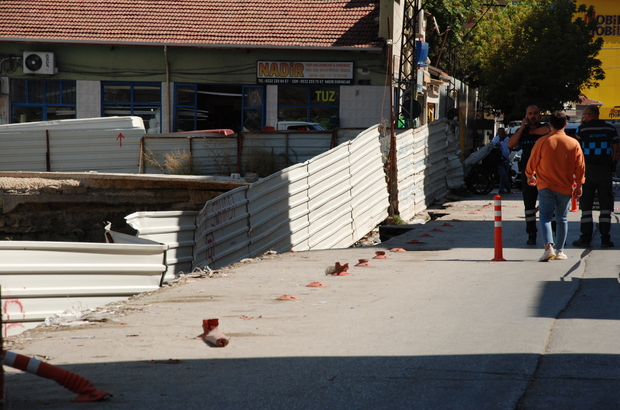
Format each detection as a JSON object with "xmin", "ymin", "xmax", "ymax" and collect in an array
[{"xmin": 538, "ymin": 188, "xmax": 571, "ymax": 251}]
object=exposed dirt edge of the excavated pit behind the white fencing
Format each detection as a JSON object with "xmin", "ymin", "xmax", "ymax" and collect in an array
[{"xmin": 0, "ymin": 176, "xmax": 227, "ymax": 243}]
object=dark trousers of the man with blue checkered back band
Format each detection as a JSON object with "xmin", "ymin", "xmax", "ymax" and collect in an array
[{"xmin": 579, "ymin": 164, "xmax": 614, "ymax": 242}]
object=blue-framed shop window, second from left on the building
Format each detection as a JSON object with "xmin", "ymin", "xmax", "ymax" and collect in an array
[{"xmin": 101, "ymin": 82, "xmax": 161, "ymax": 133}]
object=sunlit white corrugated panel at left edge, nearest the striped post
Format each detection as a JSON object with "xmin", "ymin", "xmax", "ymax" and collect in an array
[{"xmin": 0, "ymin": 241, "xmax": 168, "ymax": 335}]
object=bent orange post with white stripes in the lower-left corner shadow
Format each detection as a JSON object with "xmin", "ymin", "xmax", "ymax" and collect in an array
[{"xmin": 2, "ymin": 350, "xmax": 110, "ymax": 402}]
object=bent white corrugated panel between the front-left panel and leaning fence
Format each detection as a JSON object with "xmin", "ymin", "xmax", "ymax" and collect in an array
[{"xmin": 125, "ymin": 211, "xmax": 198, "ymax": 282}]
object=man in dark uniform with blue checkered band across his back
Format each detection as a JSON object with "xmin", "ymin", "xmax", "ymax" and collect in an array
[{"xmin": 573, "ymin": 105, "xmax": 620, "ymax": 248}]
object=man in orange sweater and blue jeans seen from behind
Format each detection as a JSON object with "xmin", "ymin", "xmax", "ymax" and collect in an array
[{"xmin": 525, "ymin": 111, "xmax": 586, "ymax": 262}]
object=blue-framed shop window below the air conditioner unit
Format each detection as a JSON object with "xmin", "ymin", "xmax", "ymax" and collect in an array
[{"xmin": 9, "ymin": 79, "xmax": 76, "ymax": 123}]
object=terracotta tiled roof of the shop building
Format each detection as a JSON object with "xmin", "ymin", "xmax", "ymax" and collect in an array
[{"xmin": 0, "ymin": 0, "xmax": 379, "ymax": 48}]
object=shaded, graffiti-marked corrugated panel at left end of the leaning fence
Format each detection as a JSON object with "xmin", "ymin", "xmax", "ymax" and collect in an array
[{"xmin": 194, "ymin": 186, "xmax": 250, "ymax": 269}]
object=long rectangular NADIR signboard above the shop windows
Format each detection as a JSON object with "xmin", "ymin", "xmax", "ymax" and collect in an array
[{"xmin": 256, "ymin": 61, "xmax": 353, "ymax": 85}]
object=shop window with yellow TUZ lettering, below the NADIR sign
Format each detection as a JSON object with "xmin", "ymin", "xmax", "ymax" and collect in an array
[{"xmin": 278, "ymin": 85, "xmax": 340, "ymax": 129}]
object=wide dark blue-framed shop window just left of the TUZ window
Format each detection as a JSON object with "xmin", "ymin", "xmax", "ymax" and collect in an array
[{"xmin": 173, "ymin": 84, "xmax": 264, "ymax": 132}]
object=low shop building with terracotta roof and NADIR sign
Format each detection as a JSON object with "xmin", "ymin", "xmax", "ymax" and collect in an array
[{"xmin": 0, "ymin": 0, "xmax": 400, "ymax": 133}]
